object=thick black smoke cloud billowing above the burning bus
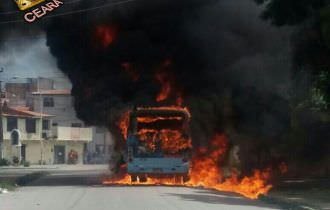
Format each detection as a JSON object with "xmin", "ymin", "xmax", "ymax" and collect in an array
[{"xmin": 39, "ymin": 0, "xmax": 290, "ymax": 148}]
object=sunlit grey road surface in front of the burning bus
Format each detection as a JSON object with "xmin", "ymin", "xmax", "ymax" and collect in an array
[{"xmin": 0, "ymin": 186, "xmax": 278, "ymax": 210}]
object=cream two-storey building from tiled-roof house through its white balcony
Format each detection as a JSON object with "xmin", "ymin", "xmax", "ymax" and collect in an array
[{"xmin": 2, "ymin": 105, "xmax": 92, "ymax": 164}]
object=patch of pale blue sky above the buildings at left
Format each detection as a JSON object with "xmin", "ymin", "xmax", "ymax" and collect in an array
[{"xmin": 0, "ymin": 34, "xmax": 71, "ymax": 89}]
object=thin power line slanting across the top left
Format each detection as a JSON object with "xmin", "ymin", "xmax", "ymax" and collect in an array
[{"xmin": 0, "ymin": 0, "xmax": 137, "ymax": 25}]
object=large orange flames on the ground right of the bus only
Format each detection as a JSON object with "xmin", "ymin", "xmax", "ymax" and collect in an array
[{"xmin": 187, "ymin": 135, "xmax": 272, "ymax": 199}]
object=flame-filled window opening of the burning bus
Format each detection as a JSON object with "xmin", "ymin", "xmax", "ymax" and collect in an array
[{"xmin": 131, "ymin": 108, "xmax": 191, "ymax": 156}]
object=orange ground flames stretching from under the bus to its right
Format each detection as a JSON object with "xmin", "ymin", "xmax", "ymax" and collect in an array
[{"xmin": 103, "ymin": 135, "xmax": 272, "ymax": 199}]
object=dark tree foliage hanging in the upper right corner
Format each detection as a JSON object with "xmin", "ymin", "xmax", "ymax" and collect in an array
[{"xmin": 255, "ymin": 0, "xmax": 330, "ymax": 111}]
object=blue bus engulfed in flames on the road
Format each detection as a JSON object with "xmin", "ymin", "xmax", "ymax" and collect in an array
[{"xmin": 126, "ymin": 107, "xmax": 192, "ymax": 182}]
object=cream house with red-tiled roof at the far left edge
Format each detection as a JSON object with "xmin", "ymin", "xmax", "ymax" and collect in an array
[{"xmin": 2, "ymin": 105, "xmax": 53, "ymax": 164}]
